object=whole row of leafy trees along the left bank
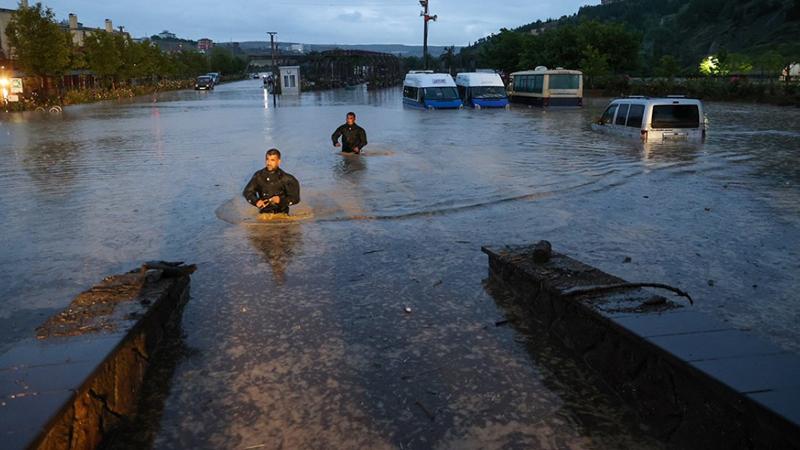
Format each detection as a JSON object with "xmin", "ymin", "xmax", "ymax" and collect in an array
[{"xmin": 6, "ymin": 3, "xmax": 247, "ymax": 93}]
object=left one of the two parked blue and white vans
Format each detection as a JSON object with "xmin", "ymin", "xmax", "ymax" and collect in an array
[{"xmin": 403, "ymin": 70, "xmax": 463, "ymax": 109}]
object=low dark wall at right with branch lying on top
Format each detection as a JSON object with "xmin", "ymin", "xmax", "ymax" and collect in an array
[{"xmin": 483, "ymin": 246, "xmax": 800, "ymax": 449}]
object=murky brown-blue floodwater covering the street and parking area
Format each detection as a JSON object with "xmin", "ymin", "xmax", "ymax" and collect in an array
[{"xmin": 0, "ymin": 81, "xmax": 800, "ymax": 448}]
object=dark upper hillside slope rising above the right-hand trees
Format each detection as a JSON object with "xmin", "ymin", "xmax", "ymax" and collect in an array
[{"xmin": 516, "ymin": 0, "xmax": 800, "ymax": 66}]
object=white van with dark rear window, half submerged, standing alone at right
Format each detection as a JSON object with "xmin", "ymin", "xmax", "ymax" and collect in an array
[{"xmin": 592, "ymin": 96, "xmax": 706, "ymax": 142}]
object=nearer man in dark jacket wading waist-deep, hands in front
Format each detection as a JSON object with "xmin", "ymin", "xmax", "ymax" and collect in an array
[{"xmin": 242, "ymin": 148, "xmax": 300, "ymax": 214}]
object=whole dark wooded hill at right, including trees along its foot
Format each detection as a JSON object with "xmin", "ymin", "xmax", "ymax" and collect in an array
[{"xmin": 459, "ymin": 0, "xmax": 800, "ymax": 82}]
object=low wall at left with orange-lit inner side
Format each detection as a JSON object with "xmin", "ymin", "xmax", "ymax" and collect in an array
[{"xmin": 0, "ymin": 263, "xmax": 194, "ymax": 449}]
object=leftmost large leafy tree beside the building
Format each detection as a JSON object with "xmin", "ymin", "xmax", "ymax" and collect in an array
[{"xmin": 6, "ymin": 3, "xmax": 72, "ymax": 88}]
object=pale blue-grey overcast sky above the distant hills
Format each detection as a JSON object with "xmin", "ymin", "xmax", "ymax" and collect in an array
[{"xmin": 0, "ymin": 0, "xmax": 600, "ymax": 45}]
